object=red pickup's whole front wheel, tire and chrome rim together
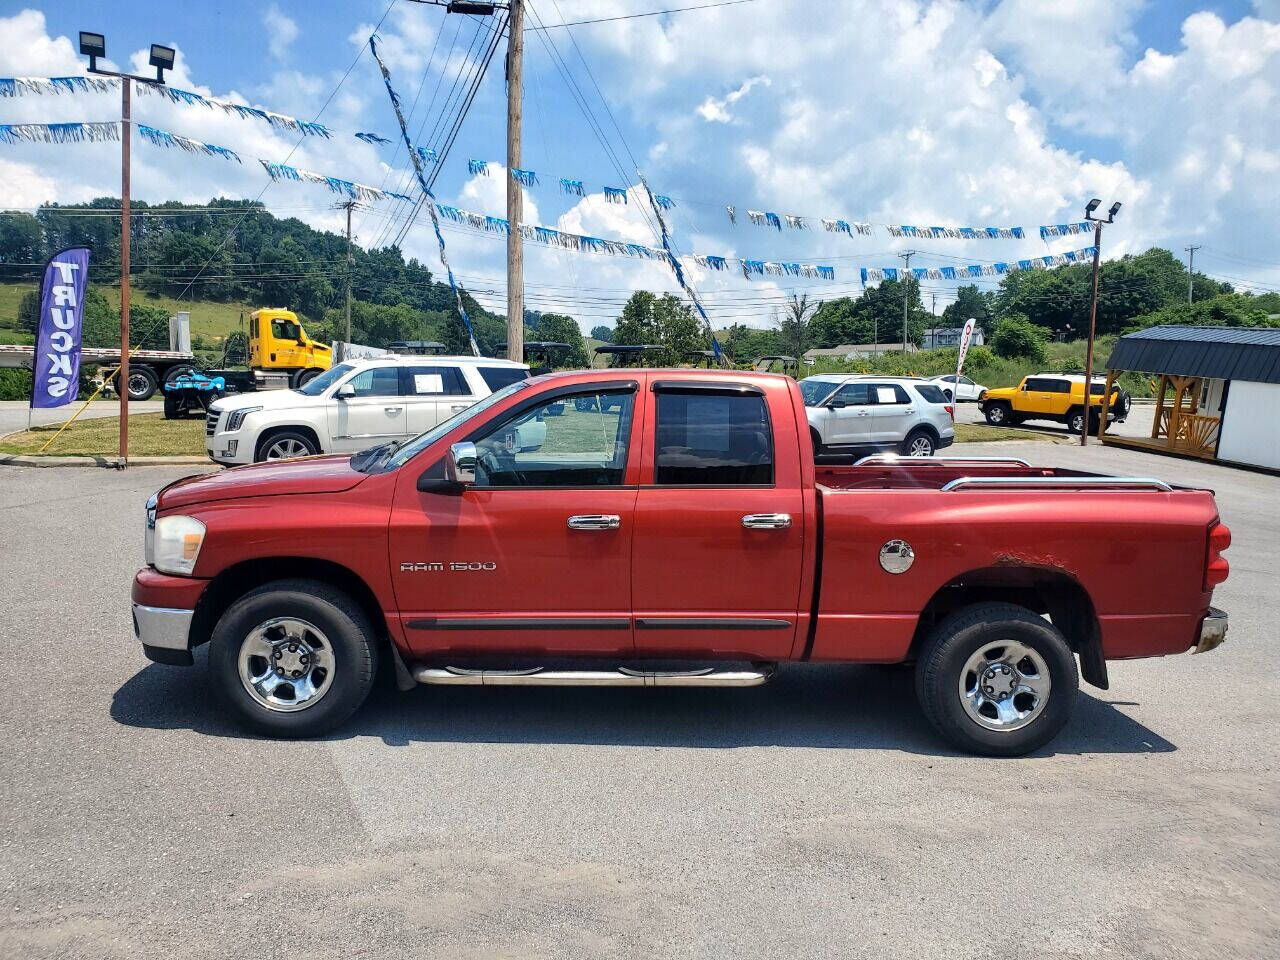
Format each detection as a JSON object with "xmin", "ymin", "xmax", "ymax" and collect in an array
[{"xmin": 209, "ymin": 580, "xmax": 378, "ymax": 739}]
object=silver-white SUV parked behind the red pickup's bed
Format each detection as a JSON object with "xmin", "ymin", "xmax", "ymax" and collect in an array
[{"xmin": 800, "ymin": 374, "xmax": 956, "ymax": 457}]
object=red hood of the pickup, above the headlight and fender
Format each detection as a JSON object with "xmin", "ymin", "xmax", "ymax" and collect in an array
[{"xmin": 156, "ymin": 454, "xmax": 367, "ymax": 511}]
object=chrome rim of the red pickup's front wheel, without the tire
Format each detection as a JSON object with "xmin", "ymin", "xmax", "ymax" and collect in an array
[{"xmin": 238, "ymin": 617, "xmax": 334, "ymax": 713}]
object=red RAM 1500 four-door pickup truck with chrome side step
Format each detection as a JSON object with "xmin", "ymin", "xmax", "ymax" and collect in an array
[{"xmin": 133, "ymin": 370, "xmax": 1230, "ymax": 755}]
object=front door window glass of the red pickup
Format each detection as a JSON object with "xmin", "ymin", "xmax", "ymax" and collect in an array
[{"xmin": 475, "ymin": 390, "xmax": 635, "ymax": 486}]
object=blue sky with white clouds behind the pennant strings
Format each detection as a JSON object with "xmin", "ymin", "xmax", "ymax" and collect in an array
[{"xmin": 0, "ymin": 0, "xmax": 1280, "ymax": 328}]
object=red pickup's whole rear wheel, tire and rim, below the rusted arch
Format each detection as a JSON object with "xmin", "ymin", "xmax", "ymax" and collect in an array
[{"xmin": 915, "ymin": 603, "xmax": 1080, "ymax": 756}]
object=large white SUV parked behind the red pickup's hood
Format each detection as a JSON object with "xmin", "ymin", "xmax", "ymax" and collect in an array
[{"xmin": 205, "ymin": 356, "xmax": 547, "ymax": 465}]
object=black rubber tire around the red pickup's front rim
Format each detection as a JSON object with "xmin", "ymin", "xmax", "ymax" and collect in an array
[{"xmin": 209, "ymin": 580, "xmax": 379, "ymax": 740}]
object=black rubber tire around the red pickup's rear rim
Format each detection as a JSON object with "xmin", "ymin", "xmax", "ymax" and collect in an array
[{"xmin": 915, "ymin": 603, "xmax": 1080, "ymax": 756}]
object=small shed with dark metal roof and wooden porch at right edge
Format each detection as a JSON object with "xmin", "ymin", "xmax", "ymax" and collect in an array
[{"xmin": 1100, "ymin": 326, "xmax": 1280, "ymax": 470}]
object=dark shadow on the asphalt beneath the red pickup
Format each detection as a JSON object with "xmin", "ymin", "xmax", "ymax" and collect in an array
[{"xmin": 111, "ymin": 650, "xmax": 1176, "ymax": 755}]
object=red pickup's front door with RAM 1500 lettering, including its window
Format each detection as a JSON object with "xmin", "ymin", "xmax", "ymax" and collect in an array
[{"xmin": 389, "ymin": 380, "xmax": 639, "ymax": 657}]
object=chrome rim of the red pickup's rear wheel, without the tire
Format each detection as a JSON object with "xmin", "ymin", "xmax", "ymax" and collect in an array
[{"xmin": 960, "ymin": 640, "xmax": 1052, "ymax": 732}]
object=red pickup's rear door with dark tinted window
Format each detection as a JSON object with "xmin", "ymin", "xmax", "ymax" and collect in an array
[{"xmin": 632, "ymin": 375, "xmax": 805, "ymax": 660}]
